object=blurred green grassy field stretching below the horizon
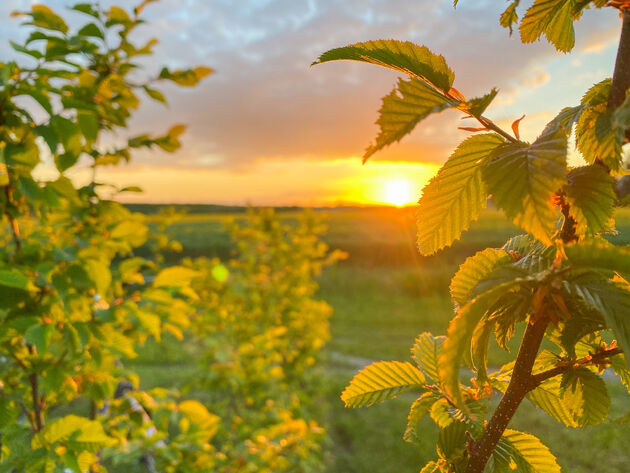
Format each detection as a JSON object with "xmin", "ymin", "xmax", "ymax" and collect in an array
[{"xmin": 140, "ymin": 209, "xmax": 630, "ymax": 473}]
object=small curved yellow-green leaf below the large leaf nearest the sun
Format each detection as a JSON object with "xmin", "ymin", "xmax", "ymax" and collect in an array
[{"xmin": 450, "ymin": 248, "xmax": 513, "ymax": 306}]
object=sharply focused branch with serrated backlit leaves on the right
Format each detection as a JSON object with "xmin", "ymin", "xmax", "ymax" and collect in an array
[{"xmin": 316, "ymin": 0, "xmax": 630, "ymax": 473}]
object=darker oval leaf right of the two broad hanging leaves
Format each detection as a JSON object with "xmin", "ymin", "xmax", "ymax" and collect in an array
[{"xmin": 564, "ymin": 165, "xmax": 616, "ymax": 235}]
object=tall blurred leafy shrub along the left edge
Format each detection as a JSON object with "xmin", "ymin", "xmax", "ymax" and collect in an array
[{"xmin": 0, "ymin": 1, "xmax": 216, "ymax": 472}]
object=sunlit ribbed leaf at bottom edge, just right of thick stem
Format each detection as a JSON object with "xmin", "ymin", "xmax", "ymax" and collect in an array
[{"xmin": 493, "ymin": 429, "xmax": 561, "ymax": 473}]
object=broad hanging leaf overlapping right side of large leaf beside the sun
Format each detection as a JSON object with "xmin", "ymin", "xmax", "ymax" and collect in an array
[{"xmin": 483, "ymin": 123, "xmax": 567, "ymax": 245}]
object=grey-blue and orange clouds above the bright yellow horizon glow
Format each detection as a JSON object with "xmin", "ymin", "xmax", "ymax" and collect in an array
[{"xmin": 0, "ymin": 0, "xmax": 619, "ymax": 203}]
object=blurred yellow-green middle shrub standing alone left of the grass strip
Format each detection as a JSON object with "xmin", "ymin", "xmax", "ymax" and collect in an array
[{"xmin": 187, "ymin": 210, "xmax": 344, "ymax": 473}]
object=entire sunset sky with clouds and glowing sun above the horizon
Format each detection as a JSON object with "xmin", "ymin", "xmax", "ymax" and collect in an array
[{"xmin": 0, "ymin": 0, "xmax": 620, "ymax": 205}]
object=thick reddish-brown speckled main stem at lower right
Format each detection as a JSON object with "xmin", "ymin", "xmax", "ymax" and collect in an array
[{"xmin": 466, "ymin": 317, "xmax": 549, "ymax": 473}]
